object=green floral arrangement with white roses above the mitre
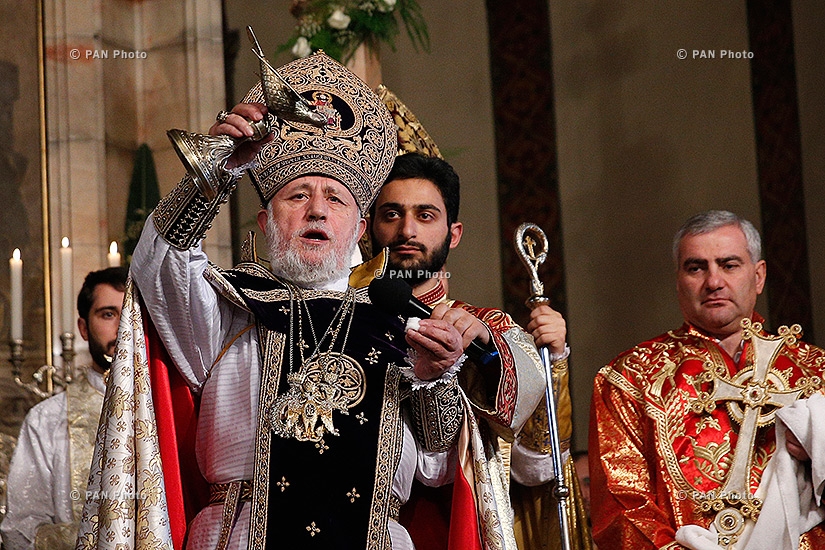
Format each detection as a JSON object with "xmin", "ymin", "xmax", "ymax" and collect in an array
[{"xmin": 278, "ymin": 0, "xmax": 430, "ymax": 63}]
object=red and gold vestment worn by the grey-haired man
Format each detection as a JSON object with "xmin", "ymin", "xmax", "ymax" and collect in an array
[{"xmin": 589, "ymin": 317, "xmax": 825, "ymax": 550}]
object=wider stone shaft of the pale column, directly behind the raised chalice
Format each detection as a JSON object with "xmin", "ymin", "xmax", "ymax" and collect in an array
[{"xmin": 102, "ymin": 0, "xmax": 232, "ymax": 267}]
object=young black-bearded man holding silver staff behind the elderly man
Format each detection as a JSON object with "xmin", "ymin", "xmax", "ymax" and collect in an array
[{"xmin": 370, "ymin": 153, "xmax": 586, "ymax": 549}]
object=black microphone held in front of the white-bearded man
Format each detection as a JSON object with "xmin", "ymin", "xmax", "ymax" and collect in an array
[{"xmin": 368, "ymin": 274, "xmax": 499, "ymax": 366}]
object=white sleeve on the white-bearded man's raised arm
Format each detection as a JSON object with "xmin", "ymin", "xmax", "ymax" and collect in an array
[{"xmin": 130, "ymin": 215, "xmax": 235, "ymax": 391}]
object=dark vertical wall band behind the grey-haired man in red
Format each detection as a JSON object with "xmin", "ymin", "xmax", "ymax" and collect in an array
[{"xmin": 747, "ymin": 0, "xmax": 814, "ymax": 341}]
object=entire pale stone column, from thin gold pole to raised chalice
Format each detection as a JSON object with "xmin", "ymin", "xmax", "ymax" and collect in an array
[{"xmin": 43, "ymin": 0, "xmax": 231, "ymax": 348}]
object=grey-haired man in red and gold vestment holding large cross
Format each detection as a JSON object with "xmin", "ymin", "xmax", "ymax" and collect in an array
[{"xmin": 589, "ymin": 211, "xmax": 825, "ymax": 550}]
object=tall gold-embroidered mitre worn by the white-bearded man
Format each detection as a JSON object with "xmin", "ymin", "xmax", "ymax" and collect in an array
[{"xmin": 244, "ymin": 51, "xmax": 398, "ymax": 212}]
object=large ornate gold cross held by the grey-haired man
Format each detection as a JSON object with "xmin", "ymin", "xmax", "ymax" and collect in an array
[{"xmin": 692, "ymin": 319, "xmax": 804, "ymax": 549}]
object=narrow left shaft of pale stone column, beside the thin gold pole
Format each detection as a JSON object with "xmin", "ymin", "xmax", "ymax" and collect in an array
[{"xmin": 44, "ymin": 0, "xmax": 108, "ymax": 358}]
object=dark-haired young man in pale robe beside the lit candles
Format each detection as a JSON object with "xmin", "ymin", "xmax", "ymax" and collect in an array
[{"xmin": 0, "ymin": 267, "xmax": 127, "ymax": 550}]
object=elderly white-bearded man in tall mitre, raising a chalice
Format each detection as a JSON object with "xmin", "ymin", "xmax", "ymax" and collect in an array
[{"xmin": 78, "ymin": 54, "xmax": 536, "ymax": 550}]
